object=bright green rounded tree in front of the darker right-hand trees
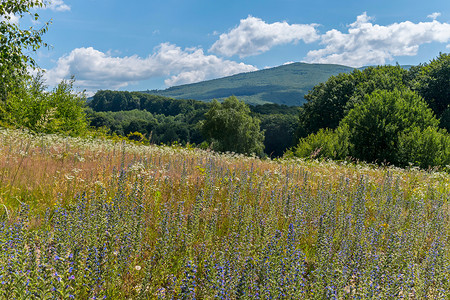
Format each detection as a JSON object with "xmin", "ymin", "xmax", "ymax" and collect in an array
[{"xmin": 341, "ymin": 90, "xmax": 439, "ymax": 164}]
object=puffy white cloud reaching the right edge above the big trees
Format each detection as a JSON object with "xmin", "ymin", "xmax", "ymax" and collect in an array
[{"xmin": 305, "ymin": 13, "xmax": 450, "ymax": 67}]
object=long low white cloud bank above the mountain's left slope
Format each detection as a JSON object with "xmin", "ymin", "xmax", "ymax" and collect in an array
[{"xmin": 45, "ymin": 43, "xmax": 257, "ymax": 91}]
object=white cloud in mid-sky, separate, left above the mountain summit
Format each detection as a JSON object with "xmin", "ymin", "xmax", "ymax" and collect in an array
[{"xmin": 209, "ymin": 16, "xmax": 319, "ymax": 58}]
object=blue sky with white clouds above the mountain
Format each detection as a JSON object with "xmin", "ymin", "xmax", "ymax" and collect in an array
[{"xmin": 13, "ymin": 0, "xmax": 450, "ymax": 95}]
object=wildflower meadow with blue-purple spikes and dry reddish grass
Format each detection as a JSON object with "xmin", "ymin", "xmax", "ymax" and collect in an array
[{"xmin": 0, "ymin": 129, "xmax": 450, "ymax": 299}]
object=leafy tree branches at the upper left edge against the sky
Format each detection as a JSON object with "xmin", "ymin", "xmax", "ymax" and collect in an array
[{"xmin": 0, "ymin": 0, "xmax": 49, "ymax": 101}]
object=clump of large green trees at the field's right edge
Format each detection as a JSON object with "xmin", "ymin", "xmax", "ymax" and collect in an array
[{"xmin": 289, "ymin": 53, "xmax": 450, "ymax": 168}]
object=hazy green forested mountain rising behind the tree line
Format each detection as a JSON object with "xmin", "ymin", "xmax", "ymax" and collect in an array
[{"xmin": 144, "ymin": 63, "xmax": 354, "ymax": 106}]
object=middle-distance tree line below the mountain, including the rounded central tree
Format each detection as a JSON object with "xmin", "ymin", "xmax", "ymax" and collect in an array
[{"xmin": 87, "ymin": 90, "xmax": 298, "ymax": 157}]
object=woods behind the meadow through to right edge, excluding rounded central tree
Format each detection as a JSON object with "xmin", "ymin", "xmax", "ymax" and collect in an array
[{"xmin": 87, "ymin": 53, "xmax": 450, "ymax": 168}]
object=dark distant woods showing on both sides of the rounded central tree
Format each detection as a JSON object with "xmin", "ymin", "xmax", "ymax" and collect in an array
[{"xmin": 88, "ymin": 91, "xmax": 298, "ymax": 157}]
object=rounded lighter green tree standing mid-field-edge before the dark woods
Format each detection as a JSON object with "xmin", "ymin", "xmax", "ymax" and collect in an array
[{"xmin": 202, "ymin": 96, "xmax": 264, "ymax": 155}]
